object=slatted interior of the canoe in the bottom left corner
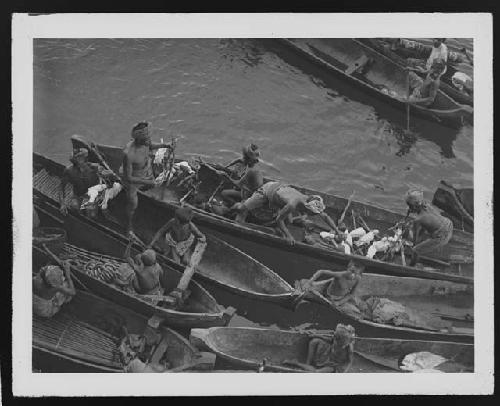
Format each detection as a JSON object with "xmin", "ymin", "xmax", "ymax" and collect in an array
[{"xmin": 33, "ymin": 280, "xmax": 197, "ymax": 372}]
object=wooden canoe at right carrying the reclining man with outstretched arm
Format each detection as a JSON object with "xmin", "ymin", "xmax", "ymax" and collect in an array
[{"xmin": 305, "ymin": 273, "xmax": 474, "ymax": 343}]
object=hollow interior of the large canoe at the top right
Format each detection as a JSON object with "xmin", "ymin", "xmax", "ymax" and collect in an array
[{"xmin": 292, "ymin": 38, "xmax": 459, "ymax": 110}]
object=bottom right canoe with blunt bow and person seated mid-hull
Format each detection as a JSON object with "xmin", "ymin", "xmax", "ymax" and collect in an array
[{"xmin": 190, "ymin": 327, "xmax": 474, "ymax": 373}]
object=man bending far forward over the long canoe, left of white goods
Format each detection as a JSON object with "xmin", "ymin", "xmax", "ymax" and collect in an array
[{"xmin": 234, "ymin": 181, "xmax": 338, "ymax": 245}]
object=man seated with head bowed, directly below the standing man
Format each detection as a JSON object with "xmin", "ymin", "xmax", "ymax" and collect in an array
[{"xmin": 148, "ymin": 207, "xmax": 206, "ymax": 265}]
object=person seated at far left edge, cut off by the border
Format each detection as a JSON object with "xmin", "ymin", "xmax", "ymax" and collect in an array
[{"xmin": 33, "ymin": 262, "xmax": 76, "ymax": 317}]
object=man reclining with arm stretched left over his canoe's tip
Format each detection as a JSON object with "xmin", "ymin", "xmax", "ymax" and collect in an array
[{"xmin": 296, "ymin": 260, "xmax": 366, "ymax": 317}]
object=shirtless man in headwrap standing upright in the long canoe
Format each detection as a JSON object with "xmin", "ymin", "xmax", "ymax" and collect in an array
[{"xmin": 123, "ymin": 122, "xmax": 172, "ymax": 237}]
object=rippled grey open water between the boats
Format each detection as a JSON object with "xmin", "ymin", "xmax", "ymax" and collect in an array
[{"xmin": 34, "ymin": 39, "xmax": 473, "ymax": 211}]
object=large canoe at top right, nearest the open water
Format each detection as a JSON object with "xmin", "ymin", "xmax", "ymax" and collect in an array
[{"xmin": 281, "ymin": 38, "xmax": 473, "ymax": 128}]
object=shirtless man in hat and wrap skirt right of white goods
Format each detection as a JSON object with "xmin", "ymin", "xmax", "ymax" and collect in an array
[{"xmin": 406, "ymin": 190, "xmax": 453, "ymax": 266}]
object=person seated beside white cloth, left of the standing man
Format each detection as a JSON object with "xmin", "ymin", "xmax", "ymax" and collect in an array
[{"xmin": 59, "ymin": 148, "xmax": 99, "ymax": 215}]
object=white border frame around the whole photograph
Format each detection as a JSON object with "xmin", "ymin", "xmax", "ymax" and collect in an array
[{"xmin": 12, "ymin": 13, "xmax": 494, "ymax": 396}]
